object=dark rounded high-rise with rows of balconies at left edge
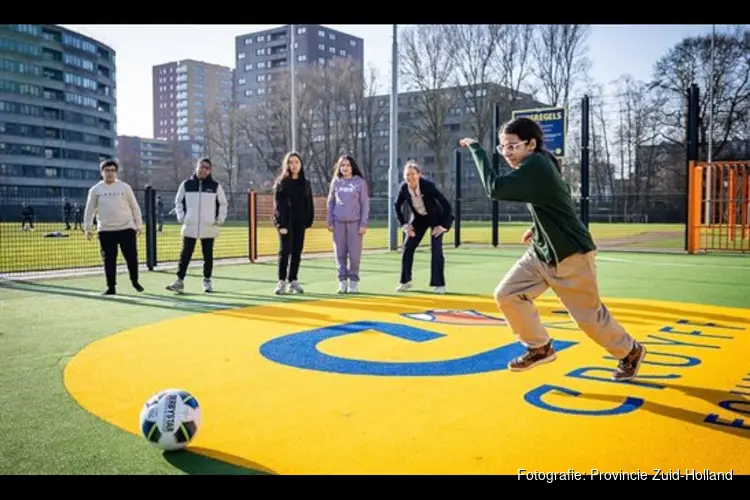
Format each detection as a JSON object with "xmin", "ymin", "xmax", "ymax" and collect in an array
[{"xmin": 0, "ymin": 24, "xmax": 116, "ymax": 205}]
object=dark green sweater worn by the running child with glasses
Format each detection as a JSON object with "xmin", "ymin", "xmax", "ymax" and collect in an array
[{"xmin": 469, "ymin": 142, "xmax": 596, "ymax": 265}]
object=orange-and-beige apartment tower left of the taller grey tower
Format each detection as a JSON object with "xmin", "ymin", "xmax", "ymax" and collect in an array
[{"xmin": 153, "ymin": 59, "xmax": 234, "ymax": 143}]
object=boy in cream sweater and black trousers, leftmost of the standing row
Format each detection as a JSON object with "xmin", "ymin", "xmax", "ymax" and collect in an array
[{"xmin": 83, "ymin": 160, "xmax": 143, "ymax": 295}]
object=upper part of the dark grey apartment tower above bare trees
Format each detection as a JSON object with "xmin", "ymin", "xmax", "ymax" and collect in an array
[{"xmin": 235, "ymin": 24, "xmax": 364, "ymax": 107}]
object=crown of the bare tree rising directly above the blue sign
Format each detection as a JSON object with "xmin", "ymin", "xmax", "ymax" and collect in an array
[{"xmin": 532, "ymin": 24, "xmax": 591, "ymax": 108}]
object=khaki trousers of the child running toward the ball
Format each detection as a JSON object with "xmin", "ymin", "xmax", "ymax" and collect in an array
[{"xmin": 495, "ymin": 248, "xmax": 634, "ymax": 359}]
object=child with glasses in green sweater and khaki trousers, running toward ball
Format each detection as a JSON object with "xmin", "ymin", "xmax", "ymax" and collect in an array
[{"xmin": 460, "ymin": 118, "xmax": 646, "ymax": 381}]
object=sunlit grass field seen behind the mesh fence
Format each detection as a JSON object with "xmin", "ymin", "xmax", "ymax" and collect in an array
[{"xmin": 0, "ymin": 221, "xmax": 685, "ymax": 273}]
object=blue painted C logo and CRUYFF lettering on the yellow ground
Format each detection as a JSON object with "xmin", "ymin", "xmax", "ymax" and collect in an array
[{"xmin": 260, "ymin": 311, "xmax": 750, "ymax": 430}]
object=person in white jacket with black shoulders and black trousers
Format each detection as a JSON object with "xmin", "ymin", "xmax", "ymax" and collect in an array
[{"xmin": 167, "ymin": 158, "xmax": 227, "ymax": 293}]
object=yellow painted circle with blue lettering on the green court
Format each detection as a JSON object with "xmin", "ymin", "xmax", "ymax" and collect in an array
[{"xmin": 65, "ymin": 294, "xmax": 750, "ymax": 475}]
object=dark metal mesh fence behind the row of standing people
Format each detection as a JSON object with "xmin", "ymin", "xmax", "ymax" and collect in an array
[{"xmin": 0, "ymin": 182, "xmax": 687, "ymax": 277}]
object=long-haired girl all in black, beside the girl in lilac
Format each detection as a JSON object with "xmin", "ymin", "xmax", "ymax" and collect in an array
[{"xmin": 273, "ymin": 152, "xmax": 315, "ymax": 294}]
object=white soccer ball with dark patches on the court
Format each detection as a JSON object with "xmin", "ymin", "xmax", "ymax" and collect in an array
[{"xmin": 140, "ymin": 389, "xmax": 201, "ymax": 451}]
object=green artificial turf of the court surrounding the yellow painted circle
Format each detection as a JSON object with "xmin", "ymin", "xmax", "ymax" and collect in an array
[{"xmin": 0, "ymin": 248, "xmax": 750, "ymax": 474}]
